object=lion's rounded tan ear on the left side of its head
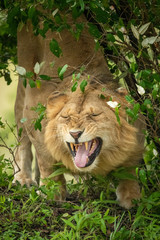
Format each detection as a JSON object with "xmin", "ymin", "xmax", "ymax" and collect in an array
[{"xmin": 47, "ymin": 91, "xmax": 68, "ymax": 118}]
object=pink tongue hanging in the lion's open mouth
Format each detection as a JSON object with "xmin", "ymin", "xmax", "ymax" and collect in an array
[{"xmin": 74, "ymin": 141, "xmax": 92, "ymax": 167}]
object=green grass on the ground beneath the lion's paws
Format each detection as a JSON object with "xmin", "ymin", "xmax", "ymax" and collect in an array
[{"xmin": 0, "ymin": 153, "xmax": 160, "ymax": 240}]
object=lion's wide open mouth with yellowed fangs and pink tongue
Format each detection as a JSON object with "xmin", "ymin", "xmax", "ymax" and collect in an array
[{"xmin": 67, "ymin": 137, "xmax": 102, "ymax": 168}]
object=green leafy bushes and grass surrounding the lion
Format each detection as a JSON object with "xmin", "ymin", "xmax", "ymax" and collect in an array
[{"xmin": 0, "ymin": 0, "xmax": 160, "ymax": 240}]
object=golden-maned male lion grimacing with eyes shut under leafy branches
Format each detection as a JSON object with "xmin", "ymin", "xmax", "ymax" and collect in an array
[{"xmin": 14, "ymin": 13, "xmax": 143, "ymax": 208}]
